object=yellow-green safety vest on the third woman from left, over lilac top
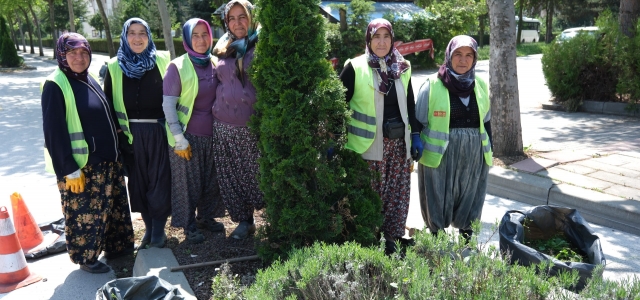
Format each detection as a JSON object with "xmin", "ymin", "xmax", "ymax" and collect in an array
[{"xmin": 165, "ymin": 53, "xmax": 216, "ymax": 147}]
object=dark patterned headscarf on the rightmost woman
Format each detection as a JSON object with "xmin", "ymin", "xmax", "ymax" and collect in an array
[{"xmin": 438, "ymin": 35, "xmax": 478, "ymax": 98}]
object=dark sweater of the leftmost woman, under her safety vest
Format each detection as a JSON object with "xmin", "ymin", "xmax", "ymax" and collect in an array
[{"xmin": 41, "ymin": 76, "xmax": 118, "ymax": 179}]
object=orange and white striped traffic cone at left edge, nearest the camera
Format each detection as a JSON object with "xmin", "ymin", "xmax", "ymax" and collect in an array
[{"xmin": 0, "ymin": 206, "xmax": 42, "ymax": 293}]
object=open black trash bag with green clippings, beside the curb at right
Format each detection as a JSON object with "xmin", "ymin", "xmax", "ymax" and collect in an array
[{"xmin": 499, "ymin": 205, "xmax": 606, "ymax": 291}]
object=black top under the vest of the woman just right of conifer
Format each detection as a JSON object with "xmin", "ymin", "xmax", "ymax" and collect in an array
[{"xmin": 340, "ymin": 63, "xmax": 422, "ymax": 132}]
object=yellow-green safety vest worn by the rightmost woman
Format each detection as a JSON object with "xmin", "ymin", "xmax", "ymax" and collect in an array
[{"xmin": 420, "ymin": 76, "xmax": 493, "ymax": 168}]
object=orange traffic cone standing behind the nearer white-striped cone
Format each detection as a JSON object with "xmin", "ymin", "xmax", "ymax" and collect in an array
[{"xmin": 11, "ymin": 193, "xmax": 44, "ymax": 253}]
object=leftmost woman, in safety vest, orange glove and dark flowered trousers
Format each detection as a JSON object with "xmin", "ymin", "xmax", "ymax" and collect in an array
[{"xmin": 41, "ymin": 33, "xmax": 134, "ymax": 273}]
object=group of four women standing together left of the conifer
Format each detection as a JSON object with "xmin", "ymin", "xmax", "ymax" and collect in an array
[{"xmin": 41, "ymin": 0, "xmax": 264, "ymax": 273}]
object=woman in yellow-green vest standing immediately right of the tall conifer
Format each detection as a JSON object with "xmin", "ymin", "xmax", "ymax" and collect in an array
[{"xmin": 340, "ymin": 19, "xmax": 422, "ymax": 255}]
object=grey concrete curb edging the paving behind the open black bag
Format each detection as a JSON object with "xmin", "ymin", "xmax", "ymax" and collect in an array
[{"xmin": 487, "ymin": 167, "xmax": 640, "ymax": 235}]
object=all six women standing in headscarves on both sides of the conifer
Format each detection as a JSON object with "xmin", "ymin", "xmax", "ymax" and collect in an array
[{"xmin": 42, "ymin": 0, "xmax": 492, "ymax": 273}]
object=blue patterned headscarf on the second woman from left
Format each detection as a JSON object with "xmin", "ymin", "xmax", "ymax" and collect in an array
[{"xmin": 118, "ymin": 18, "xmax": 156, "ymax": 79}]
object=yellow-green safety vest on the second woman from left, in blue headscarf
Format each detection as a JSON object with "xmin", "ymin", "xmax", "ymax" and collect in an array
[{"xmin": 107, "ymin": 51, "xmax": 171, "ymax": 144}]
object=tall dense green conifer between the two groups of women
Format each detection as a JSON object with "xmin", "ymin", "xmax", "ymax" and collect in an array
[{"xmin": 250, "ymin": 0, "xmax": 382, "ymax": 260}]
